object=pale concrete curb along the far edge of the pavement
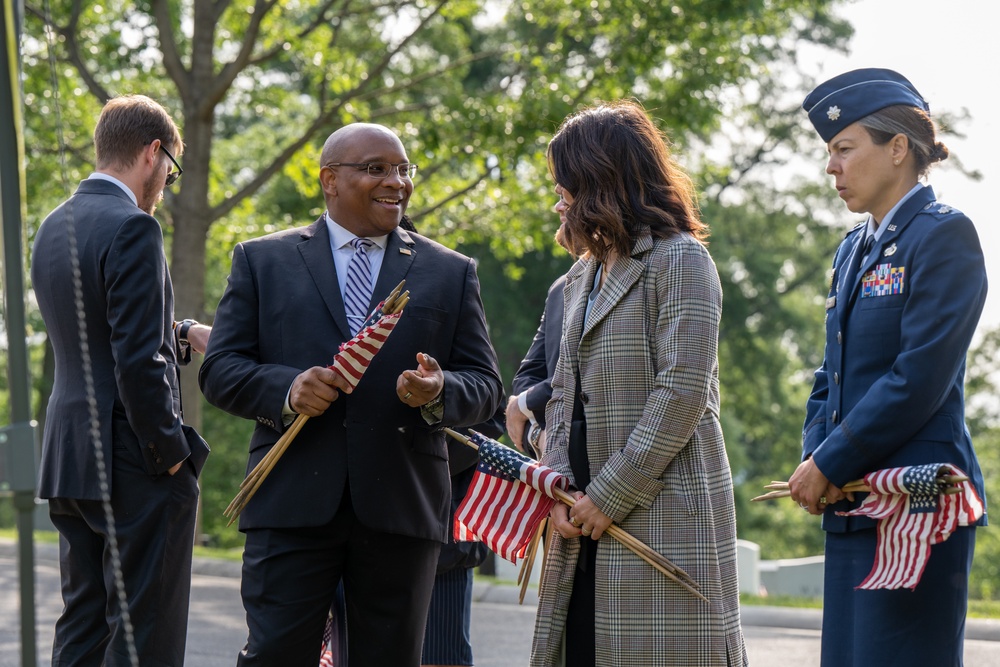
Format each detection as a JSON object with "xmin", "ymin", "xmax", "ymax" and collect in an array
[{"xmin": 0, "ymin": 538, "xmax": 1000, "ymax": 642}]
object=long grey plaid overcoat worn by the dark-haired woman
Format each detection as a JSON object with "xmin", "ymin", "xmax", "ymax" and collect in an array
[{"xmin": 531, "ymin": 232, "xmax": 747, "ymax": 667}]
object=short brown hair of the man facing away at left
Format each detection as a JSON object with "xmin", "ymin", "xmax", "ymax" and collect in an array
[{"xmin": 94, "ymin": 95, "xmax": 184, "ymax": 169}]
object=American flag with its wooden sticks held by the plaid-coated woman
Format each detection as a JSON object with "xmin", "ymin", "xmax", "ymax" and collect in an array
[{"xmin": 444, "ymin": 428, "xmax": 708, "ymax": 602}]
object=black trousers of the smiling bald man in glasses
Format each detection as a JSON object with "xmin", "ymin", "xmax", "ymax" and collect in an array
[{"xmin": 237, "ymin": 494, "xmax": 441, "ymax": 667}]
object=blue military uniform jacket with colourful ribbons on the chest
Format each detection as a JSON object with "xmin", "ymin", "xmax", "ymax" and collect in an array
[{"xmin": 803, "ymin": 187, "xmax": 986, "ymax": 531}]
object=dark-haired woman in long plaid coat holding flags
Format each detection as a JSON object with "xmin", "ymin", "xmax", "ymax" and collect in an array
[{"xmin": 531, "ymin": 101, "xmax": 747, "ymax": 667}]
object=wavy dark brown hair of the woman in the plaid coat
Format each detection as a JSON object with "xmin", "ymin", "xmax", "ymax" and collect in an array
[{"xmin": 548, "ymin": 100, "xmax": 708, "ymax": 261}]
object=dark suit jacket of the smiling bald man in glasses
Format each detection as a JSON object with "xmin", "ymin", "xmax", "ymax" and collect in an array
[{"xmin": 200, "ymin": 218, "xmax": 503, "ymax": 542}]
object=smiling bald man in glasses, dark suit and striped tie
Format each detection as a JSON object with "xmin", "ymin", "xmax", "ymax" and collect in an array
[{"xmin": 200, "ymin": 123, "xmax": 503, "ymax": 667}]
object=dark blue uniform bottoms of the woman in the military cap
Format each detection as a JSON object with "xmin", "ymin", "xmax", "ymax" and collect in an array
[{"xmin": 821, "ymin": 527, "xmax": 976, "ymax": 667}]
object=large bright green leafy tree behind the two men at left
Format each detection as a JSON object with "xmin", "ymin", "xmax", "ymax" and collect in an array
[{"xmin": 23, "ymin": 0, "xmax": 850, "ymax": 544}]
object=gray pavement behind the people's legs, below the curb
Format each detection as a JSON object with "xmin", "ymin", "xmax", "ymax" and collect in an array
[{"xmin": 0, "ymin": 540, "xmax": 1000, "ymax": 667}]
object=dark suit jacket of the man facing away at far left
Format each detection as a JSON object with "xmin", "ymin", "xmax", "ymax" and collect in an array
[{"xmin": 31, "ymin": 179, "xmax": 208, "ymax": 500}]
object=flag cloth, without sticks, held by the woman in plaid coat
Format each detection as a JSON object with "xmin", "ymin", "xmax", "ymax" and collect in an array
[{"xmin": 455, "ymin": 433, "xmax": 569, "ymax": 562}]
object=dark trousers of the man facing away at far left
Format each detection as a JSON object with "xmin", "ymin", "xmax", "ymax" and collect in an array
[{"xmin": 49, "ymin": 450, "xmax": 198, "ymax": 667}]
